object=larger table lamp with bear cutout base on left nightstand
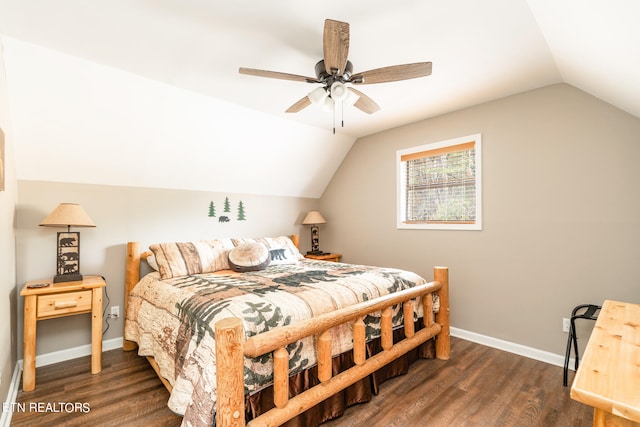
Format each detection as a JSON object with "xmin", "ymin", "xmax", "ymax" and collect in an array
[{"xmin": 40, "ymin": 203, "xmax": 96, "ymax": 283}]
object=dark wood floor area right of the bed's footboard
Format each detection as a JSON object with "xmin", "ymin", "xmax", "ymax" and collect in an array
[{"xmin": 323, "ymin": 338, "xmax": 593, "ymax": 427}]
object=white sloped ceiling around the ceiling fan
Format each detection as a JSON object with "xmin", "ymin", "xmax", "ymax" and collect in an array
[{"xmin": 0, "ymin": 0, "xmax": 640, "ymax": 197}]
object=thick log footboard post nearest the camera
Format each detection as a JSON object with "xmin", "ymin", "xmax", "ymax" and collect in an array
[{"xmin": 215, "ymin": 317, "xmax": 245, "ymax": 427}]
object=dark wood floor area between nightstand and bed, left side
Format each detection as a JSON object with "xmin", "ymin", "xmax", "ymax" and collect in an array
[{"xmin": 11, "ymin": 349, "xmax": 182, "ymax": 427}]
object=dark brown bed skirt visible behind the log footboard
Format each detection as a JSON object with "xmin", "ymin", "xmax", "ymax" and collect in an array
[{"xmin": 245, "ymin": 321, "xmax": 435, "ymax": 427}]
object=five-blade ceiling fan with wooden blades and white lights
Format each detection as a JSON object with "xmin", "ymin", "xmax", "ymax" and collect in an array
[{"xmin": 239, "ymin": 19, "xmax": 431, "ymax": 127}]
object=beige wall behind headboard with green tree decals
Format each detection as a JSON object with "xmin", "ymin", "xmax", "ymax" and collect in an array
[{"xmin": 17, "ymin": 180, "xmax": 318, "ymax": 363}]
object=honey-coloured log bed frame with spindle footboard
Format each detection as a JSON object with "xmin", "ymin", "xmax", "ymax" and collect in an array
[{"xmin": 123, "ymin": 235, "xmax": 450, "ymax": 427}]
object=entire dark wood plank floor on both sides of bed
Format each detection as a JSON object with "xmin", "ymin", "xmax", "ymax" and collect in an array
[{"xmin": 11, "ymin": 338, "xmax": 592, "ymax": 427}]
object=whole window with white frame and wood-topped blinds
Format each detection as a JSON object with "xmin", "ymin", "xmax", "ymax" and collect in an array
[{"xmin": 397, "ymin": 134, "xmax": 482, "ymax": 230}]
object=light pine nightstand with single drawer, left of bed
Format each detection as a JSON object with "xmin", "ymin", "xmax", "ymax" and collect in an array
[{"xmin": 20, "ymin": 276, "xmax": 107, "ymax": 391}]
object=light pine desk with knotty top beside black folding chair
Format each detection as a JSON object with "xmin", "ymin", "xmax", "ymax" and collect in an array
[{"xmin": 571, "ymin": 300, "xmax": 640, "ymax": 426}]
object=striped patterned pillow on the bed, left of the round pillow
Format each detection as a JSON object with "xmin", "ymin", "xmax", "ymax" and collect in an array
[{"xmin": 149, "ymin": 239, "xmax": 234, "ymax": 279}]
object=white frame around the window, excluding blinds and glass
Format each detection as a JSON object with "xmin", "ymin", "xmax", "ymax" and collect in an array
[{"xmin": 396, "ymin": 134, "xmax": 482, "ymax": 230}]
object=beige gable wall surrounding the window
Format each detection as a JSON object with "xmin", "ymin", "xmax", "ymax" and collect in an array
[{"xmin": 320, "ymin": 84, "xmax": 640, "ymax": 354}]
